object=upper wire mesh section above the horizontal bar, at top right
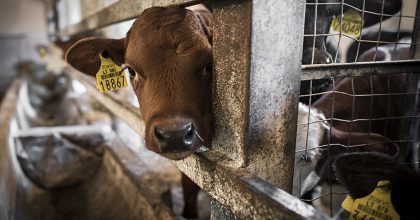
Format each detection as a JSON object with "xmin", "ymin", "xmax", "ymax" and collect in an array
[{"xmin": 303, "ymin": 0, "xmax": 420, "ymax": 65}]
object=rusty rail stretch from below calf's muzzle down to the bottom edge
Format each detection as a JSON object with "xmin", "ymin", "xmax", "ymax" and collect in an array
[{"xmin": 175, "ymin": 155, "xmax": 328, "ymax": 219}]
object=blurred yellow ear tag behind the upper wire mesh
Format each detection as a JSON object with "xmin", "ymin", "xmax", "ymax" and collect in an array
[{"xmin": 331, "ymin": 9, "xmax": 364, "ymax": 37}]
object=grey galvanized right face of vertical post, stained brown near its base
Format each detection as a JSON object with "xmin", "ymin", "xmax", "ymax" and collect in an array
[{"xmin": 247, "ymin": 0, "xmax": 305, "ymax": 192}]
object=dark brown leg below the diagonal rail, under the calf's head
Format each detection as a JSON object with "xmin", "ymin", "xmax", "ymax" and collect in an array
[{"xmin": 182, "ymin": 174, "xmax": 200, "ymax": 218}]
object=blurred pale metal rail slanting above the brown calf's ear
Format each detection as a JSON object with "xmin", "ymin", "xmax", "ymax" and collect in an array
[{"xmin": 59, "ymin": 0, "xmax": 200, "ymax": 37}]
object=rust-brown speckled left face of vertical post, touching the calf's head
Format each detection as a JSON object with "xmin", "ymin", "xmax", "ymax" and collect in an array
[{"xmin": 212, "ymin": 0, "xmax": 251, "ymax": 167}]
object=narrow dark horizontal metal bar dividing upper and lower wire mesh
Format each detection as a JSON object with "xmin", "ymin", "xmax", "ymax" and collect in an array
[{"xmin": 301, "ymin": 60, "xmax": 420, "ymax": 80}]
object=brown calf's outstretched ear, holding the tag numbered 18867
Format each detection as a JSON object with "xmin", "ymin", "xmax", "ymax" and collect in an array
[{"xmin": 66, "ymin": 37, "xmax": 125, "ymax": 76}]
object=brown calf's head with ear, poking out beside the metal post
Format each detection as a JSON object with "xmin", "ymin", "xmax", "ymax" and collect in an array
[{"xmin": 66, "ymin": 7, "xmax": 217, "ymax": 159}]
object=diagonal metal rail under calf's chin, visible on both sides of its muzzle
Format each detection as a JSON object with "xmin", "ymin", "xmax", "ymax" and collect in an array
[{"xmin": 69, "ymin": 69, "xmax": 327, "ymax": 219}]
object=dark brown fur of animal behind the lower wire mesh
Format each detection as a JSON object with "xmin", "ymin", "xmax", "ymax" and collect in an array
[{"xmin": 313, "ymin": 74, "xmax": 407, "ymax": 143}]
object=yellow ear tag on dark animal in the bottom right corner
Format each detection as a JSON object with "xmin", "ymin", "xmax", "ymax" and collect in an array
[{"xmin": 341, "ymin": 180, "xmax": 400, "ymax": 220}]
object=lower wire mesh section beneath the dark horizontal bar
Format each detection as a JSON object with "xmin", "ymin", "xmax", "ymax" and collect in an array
[{"xmin": 293, "ymin": 72, "xmax": 420, "ymax": 216}]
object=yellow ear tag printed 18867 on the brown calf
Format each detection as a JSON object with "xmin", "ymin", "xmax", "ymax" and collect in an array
[{"xmin": 96, "ymin": 53, "xmax": 127, "ymax": 93}]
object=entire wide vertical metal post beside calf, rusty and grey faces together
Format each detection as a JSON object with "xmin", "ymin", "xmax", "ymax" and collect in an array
[{"xmin": 212, "ymin": 0, "xmax": 305, "ymax": 217}]
